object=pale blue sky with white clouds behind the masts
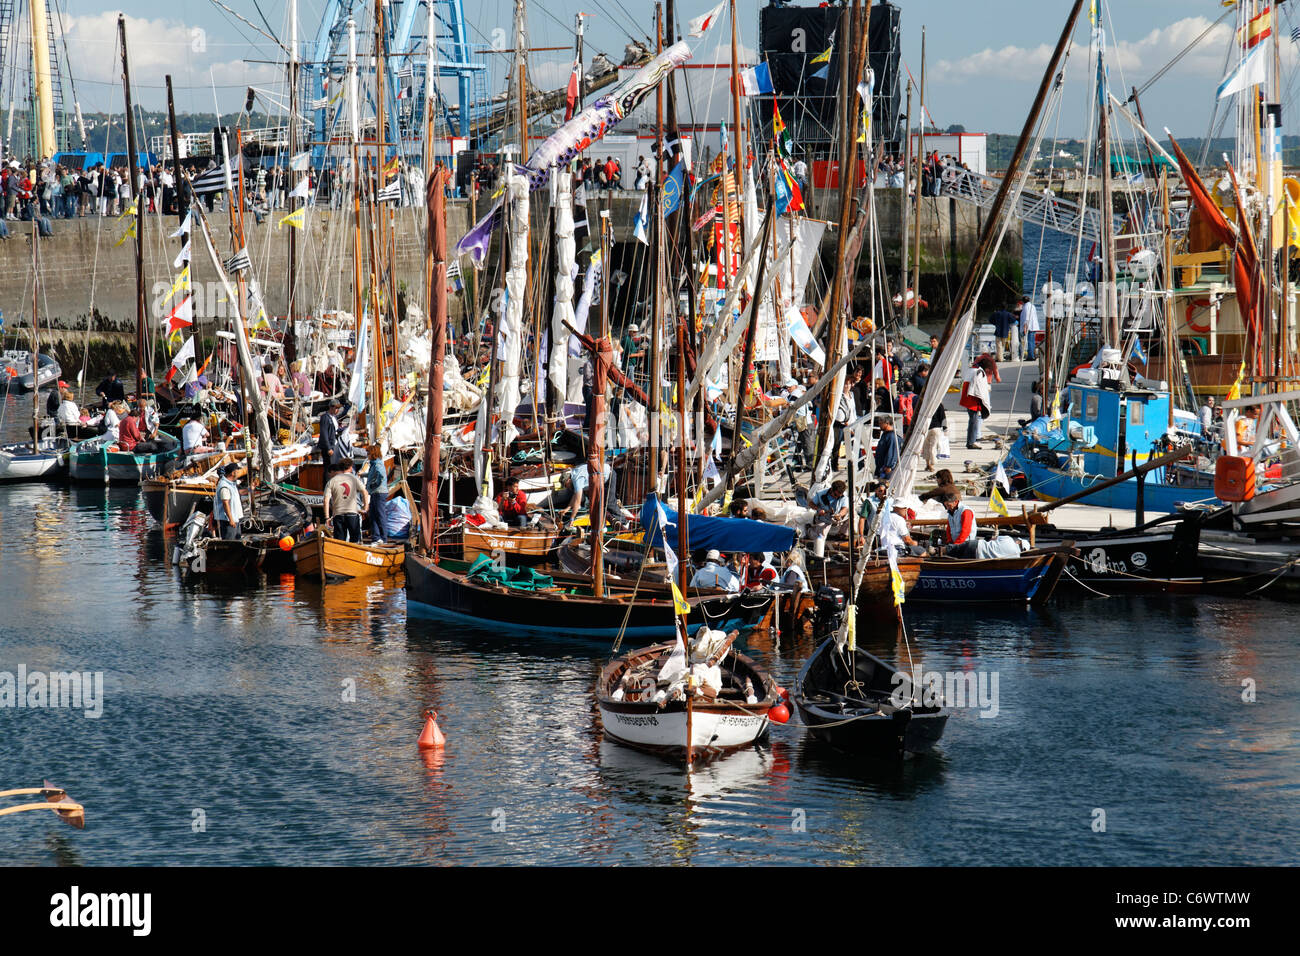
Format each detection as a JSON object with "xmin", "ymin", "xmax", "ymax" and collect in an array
[{"xmin": 50, "ymin": 0, "xmax": 1300, "ymax": 137}]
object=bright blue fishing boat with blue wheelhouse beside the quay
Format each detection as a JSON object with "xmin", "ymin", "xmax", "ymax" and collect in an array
[{"xmin": 1006, "ymin": 369, "xmax": 1221, "ymax": 514}]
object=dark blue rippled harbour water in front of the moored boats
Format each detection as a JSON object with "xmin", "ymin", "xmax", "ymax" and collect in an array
[{"xmin": 0, "ymin": 421, "xmax": 1300, "ymax": 865}]
